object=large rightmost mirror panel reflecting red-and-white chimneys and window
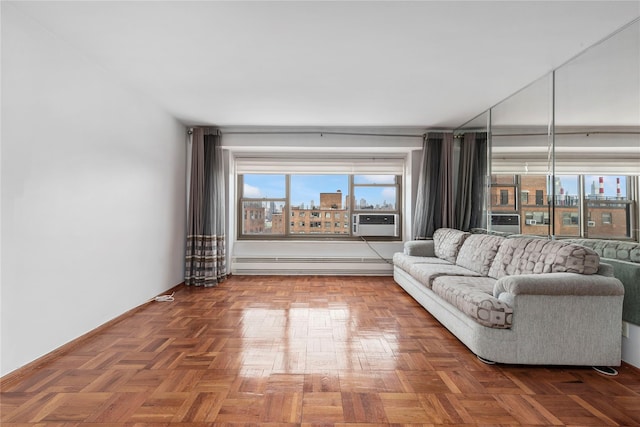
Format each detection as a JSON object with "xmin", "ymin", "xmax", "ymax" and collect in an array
[{"xmin": 555, "ymin": 21, "xmax": 640, "ymax": 239}]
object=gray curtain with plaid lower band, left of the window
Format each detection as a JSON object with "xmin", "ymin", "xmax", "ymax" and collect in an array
[{"xmin": 184, "ymin": 129, "xmax": 227, "ymax": 286}]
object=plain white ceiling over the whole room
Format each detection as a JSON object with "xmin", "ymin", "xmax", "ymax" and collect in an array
[{"xmin": 3, "ymin": 1, "xmax": 640, "ymax": 128}]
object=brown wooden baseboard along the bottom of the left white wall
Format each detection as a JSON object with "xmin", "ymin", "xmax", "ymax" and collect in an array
[{"xmin": 0, "ymin": 282, "xmax": 184, "ymax": 390}]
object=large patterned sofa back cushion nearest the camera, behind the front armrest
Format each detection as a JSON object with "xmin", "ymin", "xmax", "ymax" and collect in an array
[{"xmin": 489, "ymin": 237, "xmax": 600, "ymax": 279}]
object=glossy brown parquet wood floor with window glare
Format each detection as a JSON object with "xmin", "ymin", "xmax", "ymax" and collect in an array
[{"xmin": 0, "ymin": 276, "xmax": 640, "ymax": 427}]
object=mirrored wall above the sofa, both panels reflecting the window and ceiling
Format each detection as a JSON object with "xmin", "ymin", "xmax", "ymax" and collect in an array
[{"xmin": 478, "ymin": 17, "xmax": 640, "ymax": 240}]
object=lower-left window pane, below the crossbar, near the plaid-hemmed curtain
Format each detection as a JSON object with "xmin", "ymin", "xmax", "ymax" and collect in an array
[{"xmin": 242, "ymin": 201, "xmax": 284, "ymax": 235}]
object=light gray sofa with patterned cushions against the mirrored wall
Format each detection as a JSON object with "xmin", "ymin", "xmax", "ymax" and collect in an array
[{"xmin": 393, "ymin": 229, "xmax": 624, "ymax": 366}]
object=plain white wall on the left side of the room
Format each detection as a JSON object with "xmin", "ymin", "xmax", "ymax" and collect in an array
[{"xmin": 0, "ymin": 2, "xmax": 186, "ymax": 375}]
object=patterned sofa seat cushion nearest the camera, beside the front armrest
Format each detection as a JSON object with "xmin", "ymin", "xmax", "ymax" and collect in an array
[{"xmin": 431, "ymin": 276, "xmax": 513, "ymax": 329}]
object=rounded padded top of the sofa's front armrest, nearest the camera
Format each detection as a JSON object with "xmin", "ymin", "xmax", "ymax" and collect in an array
[{"xmin": 493, "ymin": 273, "xmax": 624, "ymax": 298}]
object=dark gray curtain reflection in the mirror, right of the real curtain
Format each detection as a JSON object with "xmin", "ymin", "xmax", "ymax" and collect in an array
[{"xmin": 455, "ymin": 132, "xmax": 487, "ymax": 231}]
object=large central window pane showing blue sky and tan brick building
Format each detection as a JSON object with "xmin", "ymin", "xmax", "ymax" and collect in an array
[{"xmin": 290, "ymin": 175, "xmax": 350, "ymax": 235}]
